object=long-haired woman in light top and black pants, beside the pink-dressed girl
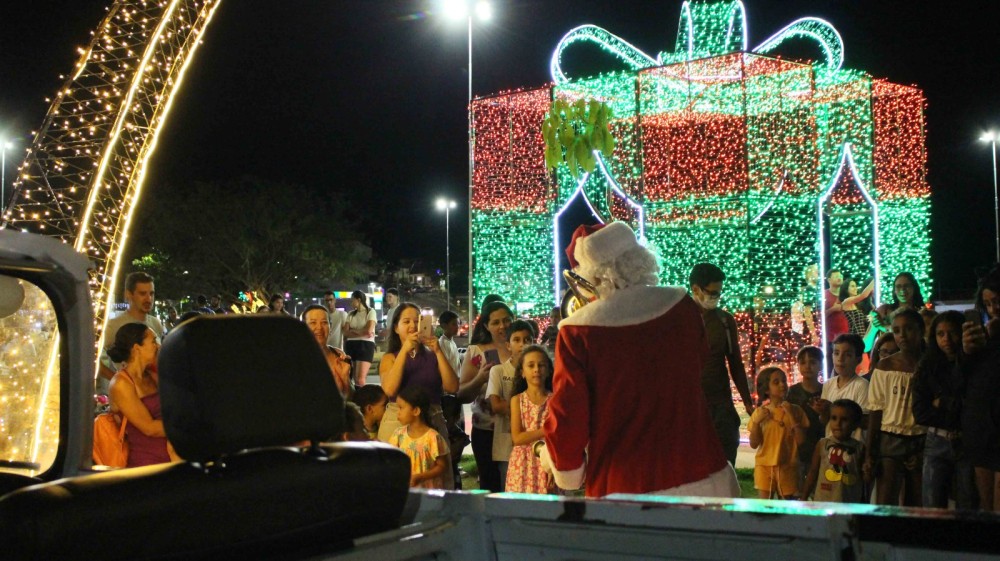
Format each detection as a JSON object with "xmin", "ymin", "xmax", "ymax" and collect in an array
[{"xmin": 458, "ymin": 302, "xmax": 514, "ymax": 493}]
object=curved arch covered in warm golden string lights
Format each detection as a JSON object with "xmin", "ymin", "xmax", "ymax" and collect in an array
[{"xmin": 0, "ymin": 0, "xmax": 221, "ymax": 374}]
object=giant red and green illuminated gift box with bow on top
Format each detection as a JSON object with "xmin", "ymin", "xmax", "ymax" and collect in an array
[{"xmin": 471, "ymin": 1, "xmax": 932, "ymax": 336}]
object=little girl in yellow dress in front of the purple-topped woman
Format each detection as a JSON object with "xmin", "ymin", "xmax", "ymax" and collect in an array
[{"xmin": 389, "ymin": 384, "xmax": 454, "ymax": 489}]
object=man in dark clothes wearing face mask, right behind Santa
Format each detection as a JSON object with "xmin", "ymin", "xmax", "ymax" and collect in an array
[{"xmin": 688, "ymin": 263, "xmax": 753, "ymax": 466}]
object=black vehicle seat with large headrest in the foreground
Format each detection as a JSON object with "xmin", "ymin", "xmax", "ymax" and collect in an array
[{"xmin": 0, "ymin": 316, "xmax": 410, "ymax": 561}]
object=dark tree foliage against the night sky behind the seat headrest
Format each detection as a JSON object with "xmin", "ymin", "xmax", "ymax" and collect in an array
[{"xmin": 130, "ymin": 177, "xmax": 370, "ymax": 296}]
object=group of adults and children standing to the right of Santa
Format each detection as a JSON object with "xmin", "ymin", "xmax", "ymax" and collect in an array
[{"xmin": 748, "ymin": 269, "xmax": 1000, "ymax": 511}]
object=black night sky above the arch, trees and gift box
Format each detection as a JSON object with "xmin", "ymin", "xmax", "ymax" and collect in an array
[{"xmin": 0, "ymin": 0, "xmax": 1000, "ymax": 297}]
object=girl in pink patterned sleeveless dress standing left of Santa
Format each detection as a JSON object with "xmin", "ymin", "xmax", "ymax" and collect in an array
[{"xmin": 507, "ymin": 345, "xmax": 555, "ymax": 494}]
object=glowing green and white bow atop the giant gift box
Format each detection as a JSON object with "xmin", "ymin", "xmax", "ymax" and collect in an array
[{"xmin": 549, "ymin": 0, "xmax": 844, "ymax": 84}]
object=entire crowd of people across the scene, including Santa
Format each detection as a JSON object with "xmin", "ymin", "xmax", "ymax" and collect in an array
[{"xmin": 98, "ymin": 241, "xmax": 1000, "ymax": 510}]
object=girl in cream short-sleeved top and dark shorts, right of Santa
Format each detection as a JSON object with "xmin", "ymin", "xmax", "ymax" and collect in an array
[{"xmin": 862, "ymin": 308, "xmax": 926, "ymax": 506}]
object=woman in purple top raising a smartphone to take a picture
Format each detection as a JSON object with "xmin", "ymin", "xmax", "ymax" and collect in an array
[{"xmin": 378, "ymin": 302, "xmax": 458, "ymax": 489}]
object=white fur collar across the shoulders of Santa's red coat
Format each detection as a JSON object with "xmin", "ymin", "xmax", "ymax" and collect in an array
[{"xmin": 559, "ymin": 286, "xmax": 687, "ymax": 327}]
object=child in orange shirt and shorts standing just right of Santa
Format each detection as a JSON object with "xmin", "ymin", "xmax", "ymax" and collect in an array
[{"xmin": 747, "ymin": 366, "xmax": 809, "ymax": 499}]
